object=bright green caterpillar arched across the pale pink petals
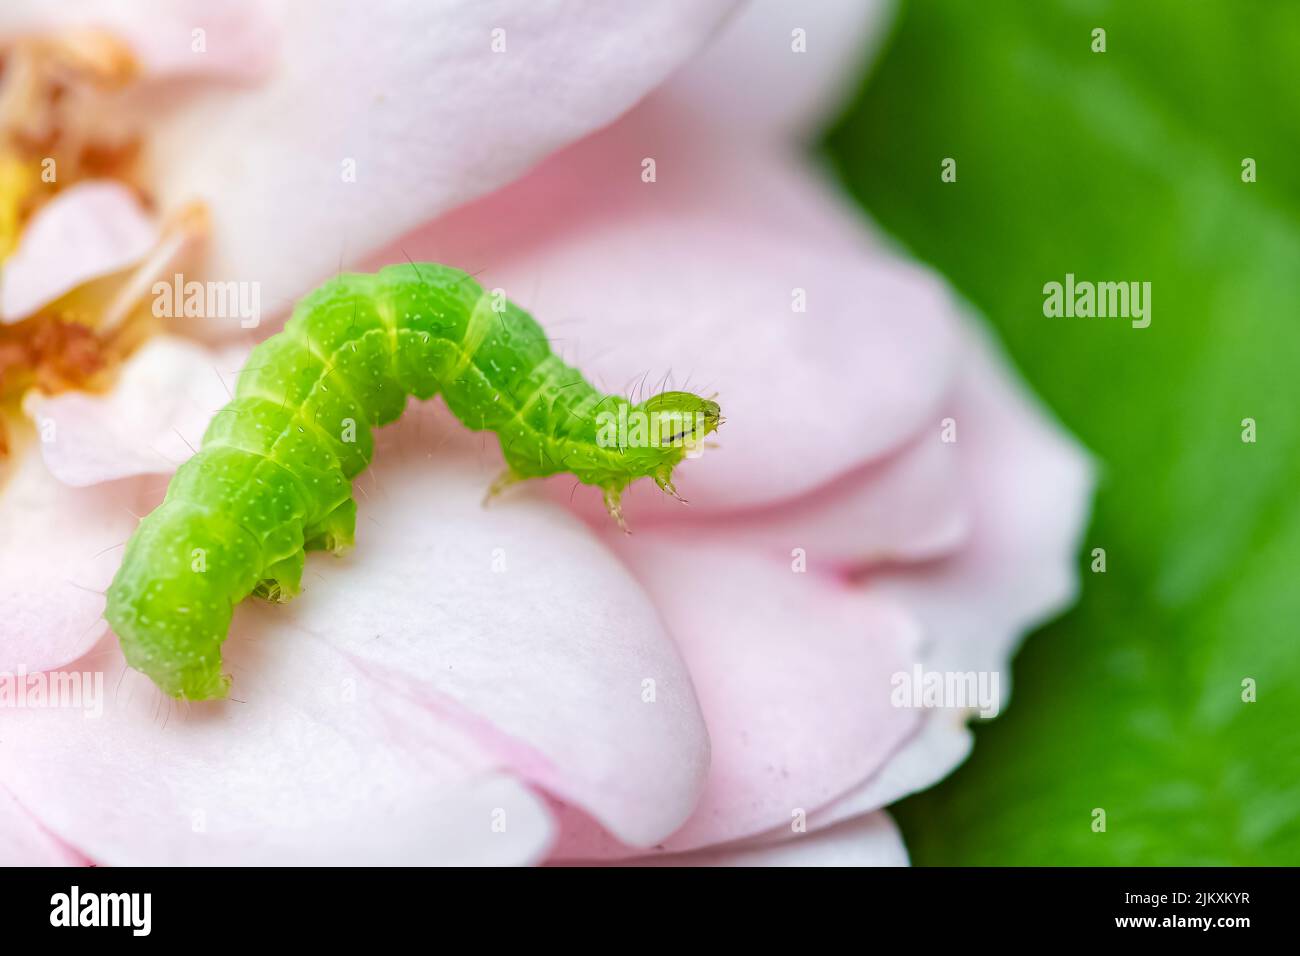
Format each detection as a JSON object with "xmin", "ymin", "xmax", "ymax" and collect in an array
[{"xmin": 104, "ymin": 263, "xmax": 722, "ymax": 700}]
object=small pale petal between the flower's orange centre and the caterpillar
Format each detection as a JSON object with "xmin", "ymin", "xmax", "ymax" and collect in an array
[{"xmin": 23, "ymin": 336, "xmax": 247, "ymax": 486}]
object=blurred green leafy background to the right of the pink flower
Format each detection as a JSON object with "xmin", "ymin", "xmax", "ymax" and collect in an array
[{"xmin": 823, "ymin": 0, "xmax": 1300, "ymax": 865}]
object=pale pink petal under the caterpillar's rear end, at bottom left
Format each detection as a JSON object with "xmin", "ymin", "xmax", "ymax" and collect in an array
[{"xmin": 0, "ymin": 647, "xmax": 551, "ymax": 866}]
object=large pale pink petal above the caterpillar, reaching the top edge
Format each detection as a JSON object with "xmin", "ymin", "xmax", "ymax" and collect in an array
[{"xmin": 129, "ymin": 0, "xmax": 735, "ymax": 306}]
